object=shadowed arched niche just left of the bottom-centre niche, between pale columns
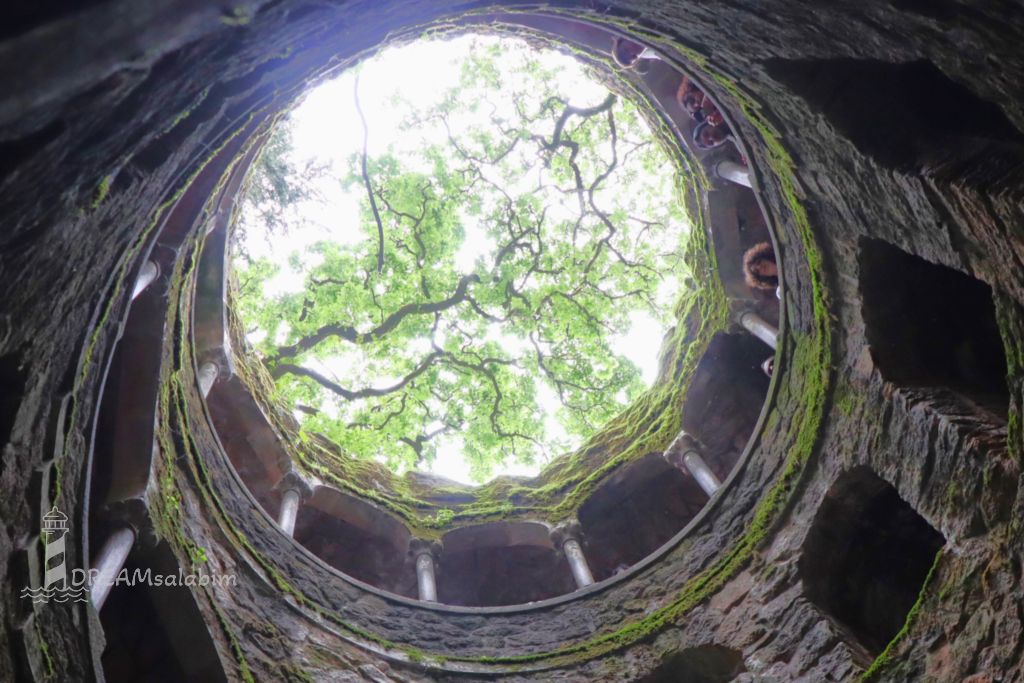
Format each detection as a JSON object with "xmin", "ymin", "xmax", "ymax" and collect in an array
[{"xmin": 295, "ymin": 486, "xmax": 416, "ymax": 597}]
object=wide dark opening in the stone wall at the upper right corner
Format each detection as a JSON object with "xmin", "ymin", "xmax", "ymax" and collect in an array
[{"xmin": 765, "ymin": 58, "xmax": 1024, "ymax": 169}]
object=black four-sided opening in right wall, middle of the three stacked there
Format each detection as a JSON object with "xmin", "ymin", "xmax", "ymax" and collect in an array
[{"xmin": 860, "ymin": 235, "xmax": 1010, "ymax": 420}]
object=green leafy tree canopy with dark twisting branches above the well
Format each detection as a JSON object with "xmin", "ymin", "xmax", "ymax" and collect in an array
[{"xmin": 234, "ymin": 38, "xmax": 688, "ymax": 480}]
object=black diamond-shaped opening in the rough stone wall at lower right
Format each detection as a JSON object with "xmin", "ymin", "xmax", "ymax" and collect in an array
[{"xmin": 800, "ymin": 467, "xmax": 945, "ymax": 655}]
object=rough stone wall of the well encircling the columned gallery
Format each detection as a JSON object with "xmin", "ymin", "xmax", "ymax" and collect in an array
[{"xmin": 0, "ymin": 0, "xmax": 1024, "ymax": 681}]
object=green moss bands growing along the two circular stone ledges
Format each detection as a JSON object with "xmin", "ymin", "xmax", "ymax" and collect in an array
[{"xmin": 153, "ymin": 15, "xmax": 839, "ymax": 669}]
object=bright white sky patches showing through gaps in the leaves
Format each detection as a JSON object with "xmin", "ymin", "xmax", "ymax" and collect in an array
[{"xmin": 239, "ymin": 36, "xmax": 678, "ymax": 484}]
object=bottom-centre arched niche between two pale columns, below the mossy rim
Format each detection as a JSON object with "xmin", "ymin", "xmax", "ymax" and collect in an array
[{"xmin": 437, "ymin": 522, "xmax": 575, "ymax": 607}]
